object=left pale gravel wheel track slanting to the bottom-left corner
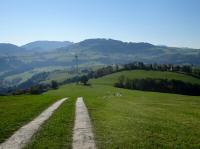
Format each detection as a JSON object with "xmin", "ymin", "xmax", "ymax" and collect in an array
[{"xmin": 0, "ymin": 98, "xmax": 67, "ymax": 149}]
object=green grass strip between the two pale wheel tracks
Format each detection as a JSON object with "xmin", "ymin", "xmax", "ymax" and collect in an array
[{"xmin": 25, "ymin": 99, "xmax": 75, "ymax": 149}]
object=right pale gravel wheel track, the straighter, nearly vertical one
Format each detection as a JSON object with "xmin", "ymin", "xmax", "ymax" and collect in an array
[{"xmin": 73, "ymin": 97, "xmax": 96, "ymax": 149}]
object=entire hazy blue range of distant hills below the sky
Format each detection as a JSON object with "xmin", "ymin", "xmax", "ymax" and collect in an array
[{"xmin": 0, "ymin": 39, "xmax": 200, "ymax": 88}]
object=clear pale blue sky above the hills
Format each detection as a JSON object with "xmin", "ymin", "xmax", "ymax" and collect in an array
[{"xmin": 0, "ymin": 0, "xmax": 200, "ymax": 48}]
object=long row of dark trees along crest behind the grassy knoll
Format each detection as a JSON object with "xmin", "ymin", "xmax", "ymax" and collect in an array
[{"xmin": 60, "ymin": 62, "xmax": 200, "ymax": 85}]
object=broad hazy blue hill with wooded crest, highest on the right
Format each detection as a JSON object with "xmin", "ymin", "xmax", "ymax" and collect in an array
[{"xmin": 57, "ymin": 39, "xmax": 200, "ymax": 64}]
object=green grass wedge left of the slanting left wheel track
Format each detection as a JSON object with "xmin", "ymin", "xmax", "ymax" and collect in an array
[{"xmin": 0, "ymin": 91, "xmax": 62, "ymax": 142}]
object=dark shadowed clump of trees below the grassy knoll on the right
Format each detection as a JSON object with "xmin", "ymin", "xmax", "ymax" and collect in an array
[{"xmin": 115, "ymin": 76, "xmax": 200, "ymax": 96}]
